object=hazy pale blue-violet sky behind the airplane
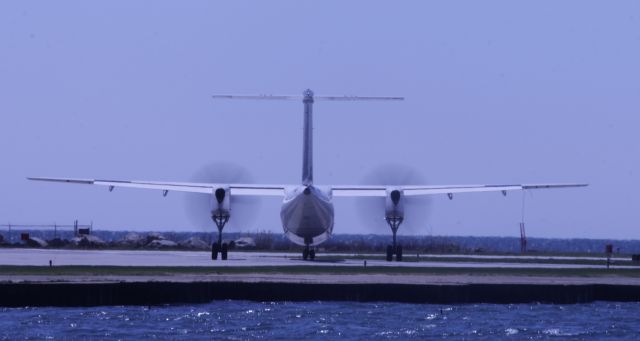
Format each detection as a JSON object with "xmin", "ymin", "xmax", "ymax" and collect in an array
[{"xmin": 0, "ymin": 0, "xmax": 640, "ymax": 239}]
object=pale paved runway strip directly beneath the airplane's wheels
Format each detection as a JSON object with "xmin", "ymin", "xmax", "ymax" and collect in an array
[{"xmin": 0, "ymin": 248, "xmax": 638, "ymax": 269}]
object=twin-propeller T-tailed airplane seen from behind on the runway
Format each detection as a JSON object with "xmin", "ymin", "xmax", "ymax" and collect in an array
[{"xmin": 27, "ymin": 89, "xmax": 587, "ymax": 261}]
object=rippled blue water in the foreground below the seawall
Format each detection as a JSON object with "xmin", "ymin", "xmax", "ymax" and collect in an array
[{"xmin": 0, "ymin": 301, "xmax": 640, "ymax": 340}]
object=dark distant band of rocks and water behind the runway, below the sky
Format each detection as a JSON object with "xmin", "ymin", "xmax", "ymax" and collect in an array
[{"xmin": 0, "ymin": 228, "xmax": 640, "ymax": 256}]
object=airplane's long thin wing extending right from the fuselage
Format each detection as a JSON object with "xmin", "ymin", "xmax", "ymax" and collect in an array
[{"xmin": 332, "ymin": 184, "xmax": 587, "ymax": 197}]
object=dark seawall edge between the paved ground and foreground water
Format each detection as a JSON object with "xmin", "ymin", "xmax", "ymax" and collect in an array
[{"xmin": 0, "ymin": 281, "xmax": 640, "ymax": 307}]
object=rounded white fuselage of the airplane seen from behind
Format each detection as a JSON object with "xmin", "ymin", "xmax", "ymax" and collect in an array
[{"xmin": 280, "ymin": 185, "xmax": 334, "ymax": 246}]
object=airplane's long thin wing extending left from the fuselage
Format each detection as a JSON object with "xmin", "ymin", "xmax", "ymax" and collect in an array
[{"xmin": 27, "ymin": 177, "xmax": 286, "ymax": 196}]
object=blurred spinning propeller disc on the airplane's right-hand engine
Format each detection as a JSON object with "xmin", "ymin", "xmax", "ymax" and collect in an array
[{"xmin": 356, "ymin": 164, "xmax": 431, "ymax": 234}]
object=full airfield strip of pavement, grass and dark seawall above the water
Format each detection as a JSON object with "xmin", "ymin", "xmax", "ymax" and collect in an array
[{"xmin": 0, "ymin": 248, "xmax": 640, "ymax": 307}]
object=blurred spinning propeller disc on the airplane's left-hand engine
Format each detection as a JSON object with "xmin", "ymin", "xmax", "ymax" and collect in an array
[{"xmin": 185, "ymin": 162, "xmax": 262, "ymax": 232}]
